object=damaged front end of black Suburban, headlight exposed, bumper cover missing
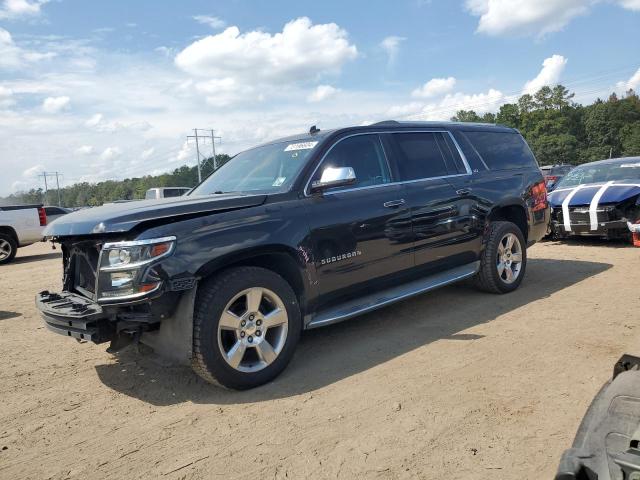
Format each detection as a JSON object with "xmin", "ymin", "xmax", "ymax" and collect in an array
[{"xmin": 36, "ymin": 236, "xmax": 196, "ymax": 358}]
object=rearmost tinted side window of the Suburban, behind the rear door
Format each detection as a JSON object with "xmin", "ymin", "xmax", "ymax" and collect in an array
[{"xmin": 464, "ymin": 132, "xmax": 537, "ymax": 170}]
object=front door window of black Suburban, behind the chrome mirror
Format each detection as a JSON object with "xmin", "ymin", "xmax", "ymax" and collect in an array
[{"xmin": 311, "ymin": 134, "xmax": 391, "ymax": 191}]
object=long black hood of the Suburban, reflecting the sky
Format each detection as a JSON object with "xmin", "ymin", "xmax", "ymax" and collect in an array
[{"xmin": 44, "ymin": 194, "xmax": 267, "ymax": 237}]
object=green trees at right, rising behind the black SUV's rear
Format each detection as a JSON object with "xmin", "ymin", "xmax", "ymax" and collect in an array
[{"xmin": 452, "ymin": 85, "xmax": 640, "ymax": 165}]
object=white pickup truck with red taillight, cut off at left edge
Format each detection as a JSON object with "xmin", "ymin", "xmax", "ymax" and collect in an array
[{"xmin": 0, "ymin": 205, "xmax": 47, "ymax": 265}]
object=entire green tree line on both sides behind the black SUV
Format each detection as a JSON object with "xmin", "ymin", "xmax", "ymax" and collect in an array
[{"xmin": 0, "ymin": 85, "xmax": 640, "ymax": 207}]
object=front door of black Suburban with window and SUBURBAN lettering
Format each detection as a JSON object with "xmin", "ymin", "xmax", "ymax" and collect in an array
[{"xmin": 307, "ymin": 133, "xmax": 413, "ymax": 303}]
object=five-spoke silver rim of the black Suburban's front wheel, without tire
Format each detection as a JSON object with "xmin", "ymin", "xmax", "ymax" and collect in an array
[{"xmin": 218, "ymin": 287, "xmax": 289, "ymax": 373}]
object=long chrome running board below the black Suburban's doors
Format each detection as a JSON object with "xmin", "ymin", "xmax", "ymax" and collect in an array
[{"xmin": 305, "ymin": 262, "xmax": 480, "ymax": 329}]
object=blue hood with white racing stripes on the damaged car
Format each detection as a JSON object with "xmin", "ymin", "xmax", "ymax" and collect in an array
[{"xmin": 549, "ymin": 180, "xmax": 640, "ymax": 207}]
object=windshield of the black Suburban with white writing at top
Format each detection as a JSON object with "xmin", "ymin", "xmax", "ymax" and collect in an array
[{"xmin": 192, "ymin": 142, "xmax": 318, "ymax": 195}]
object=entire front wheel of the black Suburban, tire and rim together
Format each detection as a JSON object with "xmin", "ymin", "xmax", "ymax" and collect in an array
[{"xmin": 192, "ymin": 267, "xmax": 302, "ymax": 390}]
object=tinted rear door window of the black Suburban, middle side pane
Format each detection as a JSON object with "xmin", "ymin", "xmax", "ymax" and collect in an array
[{"xmin": 393, "ymin": 133, "xmax": 449, "ymax": 181}]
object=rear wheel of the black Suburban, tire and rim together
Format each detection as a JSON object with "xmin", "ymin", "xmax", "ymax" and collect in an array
[{"xmin": 474, "ymin": 221, "xmax": 527, "ymax": 293}]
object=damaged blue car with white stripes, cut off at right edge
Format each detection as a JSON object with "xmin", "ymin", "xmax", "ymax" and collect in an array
[{"xmin": 548, "ymin": 157, "xmax": 640, "ymax": 239}]
